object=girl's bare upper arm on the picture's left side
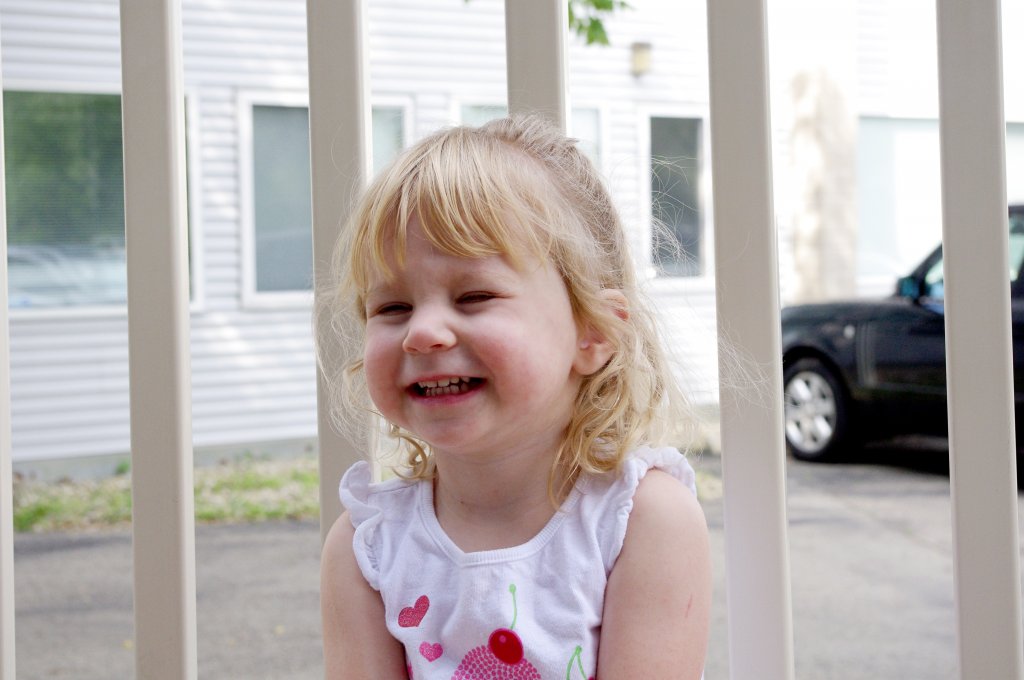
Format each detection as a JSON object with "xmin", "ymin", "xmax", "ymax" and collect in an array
[{"xmin": 321, "ymin": 512, "xmax": 409, "ymax": 680}]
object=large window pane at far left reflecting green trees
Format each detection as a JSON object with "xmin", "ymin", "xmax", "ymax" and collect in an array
[{"xmin": 3, "ymin": 92, "xmax": 127, "ymax": 307}]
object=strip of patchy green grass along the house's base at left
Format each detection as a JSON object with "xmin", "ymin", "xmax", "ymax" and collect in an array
[{"xmin": 14, "ymin": 457, "xmax": 319, "ymax": 532}]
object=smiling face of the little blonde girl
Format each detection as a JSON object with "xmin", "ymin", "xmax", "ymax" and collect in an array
[{"xmin": 364, "ymin": 218, "xmax": 590, "ymax": 462}]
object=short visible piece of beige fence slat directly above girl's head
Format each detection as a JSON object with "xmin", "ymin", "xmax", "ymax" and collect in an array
[{"xmin": 505, "ymin": 0, "xmax": 568, "ymax": 130}]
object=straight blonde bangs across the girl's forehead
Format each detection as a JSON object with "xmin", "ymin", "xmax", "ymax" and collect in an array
[{"xmin": 348, "ymin": 128, "xmax": 556, "ymax": 295}]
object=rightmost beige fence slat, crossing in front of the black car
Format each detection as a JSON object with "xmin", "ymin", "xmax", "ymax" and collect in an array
[{"xmin": 937, "ymin": 0, "xmax": 1022, "ymax": 680}]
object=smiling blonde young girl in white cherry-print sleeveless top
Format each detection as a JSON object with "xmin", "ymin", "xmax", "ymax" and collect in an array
[{"xmin": 321, "ymin": 118, "xmax": 711, "ymax": 680}]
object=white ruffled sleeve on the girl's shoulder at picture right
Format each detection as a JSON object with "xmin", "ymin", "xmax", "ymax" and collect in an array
[{"xmin": 602, "ymin": 447, "xmax": 697, "ymax": 570}]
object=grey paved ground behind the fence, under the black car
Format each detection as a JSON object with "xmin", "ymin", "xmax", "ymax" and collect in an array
[{"xmin": 8, "ymin": 449, "xmax": 1015, "ymax": 680}]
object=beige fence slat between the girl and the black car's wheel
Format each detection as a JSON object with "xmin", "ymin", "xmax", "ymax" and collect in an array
[{"xmin": 708, "ymin": 0, "xmax": 794, "ymax": 680}]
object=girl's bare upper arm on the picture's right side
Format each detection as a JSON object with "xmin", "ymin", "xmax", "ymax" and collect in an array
[{"xmin": 597, "ymin": 470, "xmax": 712, "ymax": 680}]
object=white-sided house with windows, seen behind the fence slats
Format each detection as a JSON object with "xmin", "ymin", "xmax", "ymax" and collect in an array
[{"xmin": 6, "ymin": 0, "xmax": 1024, "ymax": 463}]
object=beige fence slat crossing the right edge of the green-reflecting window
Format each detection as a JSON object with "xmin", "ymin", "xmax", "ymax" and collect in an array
[{"xmin": 121, "ymin": 0, "xmax": 197, "ymax": 679}]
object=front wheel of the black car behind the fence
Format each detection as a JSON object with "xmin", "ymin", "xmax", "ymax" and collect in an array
[{"xmin": 782, "ymin": 357, "xmax": 851, "ymax": 462}]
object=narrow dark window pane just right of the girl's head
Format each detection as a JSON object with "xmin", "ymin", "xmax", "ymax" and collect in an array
[{"xmin": 650, "ymin": 118, "xmax": 703, "ymax": 277}]
